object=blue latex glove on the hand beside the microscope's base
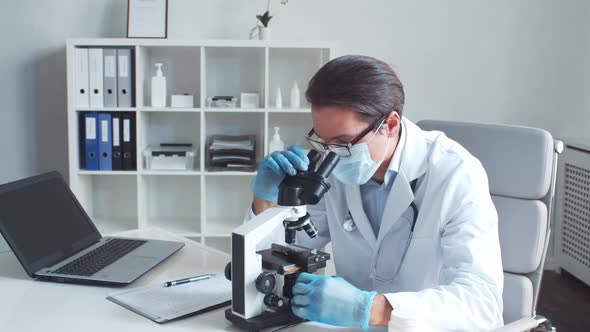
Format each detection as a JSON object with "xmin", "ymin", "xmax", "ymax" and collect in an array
[{"xmin": 291, "ymin": 273, "xmax": 377, "ymax": 331}]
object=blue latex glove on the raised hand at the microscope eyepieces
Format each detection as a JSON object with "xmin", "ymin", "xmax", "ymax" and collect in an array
[{"xmin": 251, "ymin": 145, "xmax": 309, "ymax": 202}]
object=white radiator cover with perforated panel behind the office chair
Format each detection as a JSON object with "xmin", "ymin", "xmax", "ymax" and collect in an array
[{"xmin": 556, "ymin": 142, "xmax": 590, "ymax": 285}]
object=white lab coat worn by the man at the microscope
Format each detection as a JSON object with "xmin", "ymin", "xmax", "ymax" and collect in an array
[{"xmin": 298, "ymin": 118, "xmax": 503, "ymax": 332}]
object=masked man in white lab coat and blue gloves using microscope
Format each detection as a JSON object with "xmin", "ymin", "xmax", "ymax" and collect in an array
[{"xmin": 252, "ymin": 56, "xmax": 503, "ymax": 331}]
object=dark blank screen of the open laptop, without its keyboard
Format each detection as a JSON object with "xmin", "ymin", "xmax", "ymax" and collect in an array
[{"xmin": 0, "ymin": 172, "xmax": 101, "ymax": 276}]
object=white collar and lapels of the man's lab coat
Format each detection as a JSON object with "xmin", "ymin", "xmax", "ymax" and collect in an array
[{"xmin": 344, "ymin": 117, "xmax": 427, "ymax": 249}]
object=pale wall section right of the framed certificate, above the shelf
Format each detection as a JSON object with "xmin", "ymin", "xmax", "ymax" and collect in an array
[{"xmin": 170, "ymin": 0, "xmax": 590, "ymax": 136}]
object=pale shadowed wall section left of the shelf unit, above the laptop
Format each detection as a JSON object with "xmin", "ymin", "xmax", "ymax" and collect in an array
[{"xmin": 0, "ymin": 0, "xmax": 127, "ymax": 251}]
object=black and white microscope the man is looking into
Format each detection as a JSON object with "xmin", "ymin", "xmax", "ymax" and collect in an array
[{"xmin": 225, "ymin": 150, "xmax": 340, "ymax": 331}]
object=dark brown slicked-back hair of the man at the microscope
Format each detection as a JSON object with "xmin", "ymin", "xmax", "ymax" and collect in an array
[{"xmin": 305, "ymin": 55, "xmax": 405, "ymax": 122}]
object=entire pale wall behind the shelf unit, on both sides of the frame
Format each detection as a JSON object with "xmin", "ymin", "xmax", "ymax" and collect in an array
[{"xmin": 0, "ymin": 0, "xmax": 590, "ymax": 253}]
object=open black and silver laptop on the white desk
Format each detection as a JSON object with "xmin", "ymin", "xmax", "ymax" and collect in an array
[{"xmin": 0, "ymin": 172, "xmax": 184, "ymax": 286}]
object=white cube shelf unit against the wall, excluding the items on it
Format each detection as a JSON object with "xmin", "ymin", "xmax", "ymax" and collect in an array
[{"xmin": 67, "ymin": 39, "xmax": 333, "ymax": 252}]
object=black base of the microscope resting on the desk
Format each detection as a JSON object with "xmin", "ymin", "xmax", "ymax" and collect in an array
[{"xmin": 225, "ymin": 309, "xmax": 303, "ymax": 331}]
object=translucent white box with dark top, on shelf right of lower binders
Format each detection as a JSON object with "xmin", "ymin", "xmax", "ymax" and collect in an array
[{"xmin": 143, "ymin": 144, "xmax": 197, "ymax": 171}]
